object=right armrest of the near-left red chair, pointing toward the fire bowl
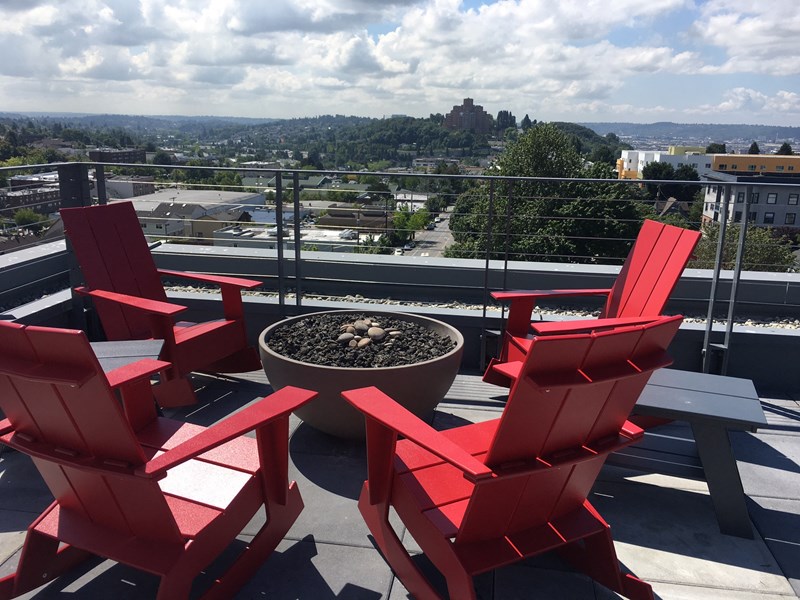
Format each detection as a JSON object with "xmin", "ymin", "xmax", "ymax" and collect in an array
[{"xmin": 136, "ymin": 386, "xmax": 317, "ymax": 478}]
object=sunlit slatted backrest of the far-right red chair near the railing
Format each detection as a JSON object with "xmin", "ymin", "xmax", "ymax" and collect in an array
[{"xmin": 600, "ymin": 220, "xmax": 701, "ymax": 317}]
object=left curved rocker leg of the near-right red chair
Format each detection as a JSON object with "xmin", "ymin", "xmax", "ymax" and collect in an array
[{"xmin": 358, "ymin": 483, "xmax": 454, "ymax": 600}]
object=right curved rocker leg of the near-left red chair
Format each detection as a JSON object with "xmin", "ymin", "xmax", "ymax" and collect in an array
[{"xmin": 202, "ymin": 482, "xmax": 303, "ymax": 600}]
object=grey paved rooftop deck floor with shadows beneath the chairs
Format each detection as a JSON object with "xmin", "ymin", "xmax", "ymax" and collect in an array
[{"xmin": 0, "ymin": 371, "xmax": 800, "ymax": 600}]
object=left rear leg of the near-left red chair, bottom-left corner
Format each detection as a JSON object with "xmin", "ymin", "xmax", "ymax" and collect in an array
[{"xmin": 5, "ymin": 527, "xmax": 92, "ymax": 598}]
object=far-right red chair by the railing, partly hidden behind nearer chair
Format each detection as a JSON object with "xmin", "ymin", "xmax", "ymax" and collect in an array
[{"xmin": 483, "ymin": 220, "xmax": 701, "ymax": 386}]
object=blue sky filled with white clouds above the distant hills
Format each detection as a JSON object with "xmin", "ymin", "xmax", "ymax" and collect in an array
[{"xmin": 0, "ymin": 0, "xmax": 800, "ymax": 126}]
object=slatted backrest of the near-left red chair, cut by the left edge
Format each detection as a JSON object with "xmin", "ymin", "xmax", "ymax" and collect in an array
[{"xmin": 0, "ymin": 322, "xmax": 181, "ymax": 543}]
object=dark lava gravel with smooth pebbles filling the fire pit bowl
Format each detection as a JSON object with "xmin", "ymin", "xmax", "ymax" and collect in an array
[{"xmin": 267, "ymin": 312, "xmax": 456, "ymax": 368}]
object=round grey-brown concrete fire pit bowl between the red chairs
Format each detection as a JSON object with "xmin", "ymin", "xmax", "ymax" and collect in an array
[{"xmin": 258, "ymin": 310, "xmax": 464, "ymax": 439}]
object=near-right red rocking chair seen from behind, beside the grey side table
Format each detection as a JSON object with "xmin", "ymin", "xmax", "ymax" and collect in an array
[{"xmin": 343, "ymin": 317, "xmax": 681, "ymax": 600}]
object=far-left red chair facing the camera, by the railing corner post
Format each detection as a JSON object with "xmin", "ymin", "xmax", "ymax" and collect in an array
[{"xmin": 61, "ymin": 202, "xmax": 261, "ymax": 406}]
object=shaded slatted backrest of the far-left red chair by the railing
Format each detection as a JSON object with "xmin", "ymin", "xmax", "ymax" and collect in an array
[{"xmin": 61, "ymin": 202, "xmax": 167, "ymax": 340}]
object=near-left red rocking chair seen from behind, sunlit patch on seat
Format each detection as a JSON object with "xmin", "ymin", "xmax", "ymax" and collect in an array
[{"xmin": 0, "ymin": 322, "xmax": 316, "ymax": 600}]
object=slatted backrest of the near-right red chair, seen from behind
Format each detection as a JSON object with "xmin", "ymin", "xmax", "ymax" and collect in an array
[{"xmin": 456, "ymin": 316, "xmax": 682, "ymax": 543}]
